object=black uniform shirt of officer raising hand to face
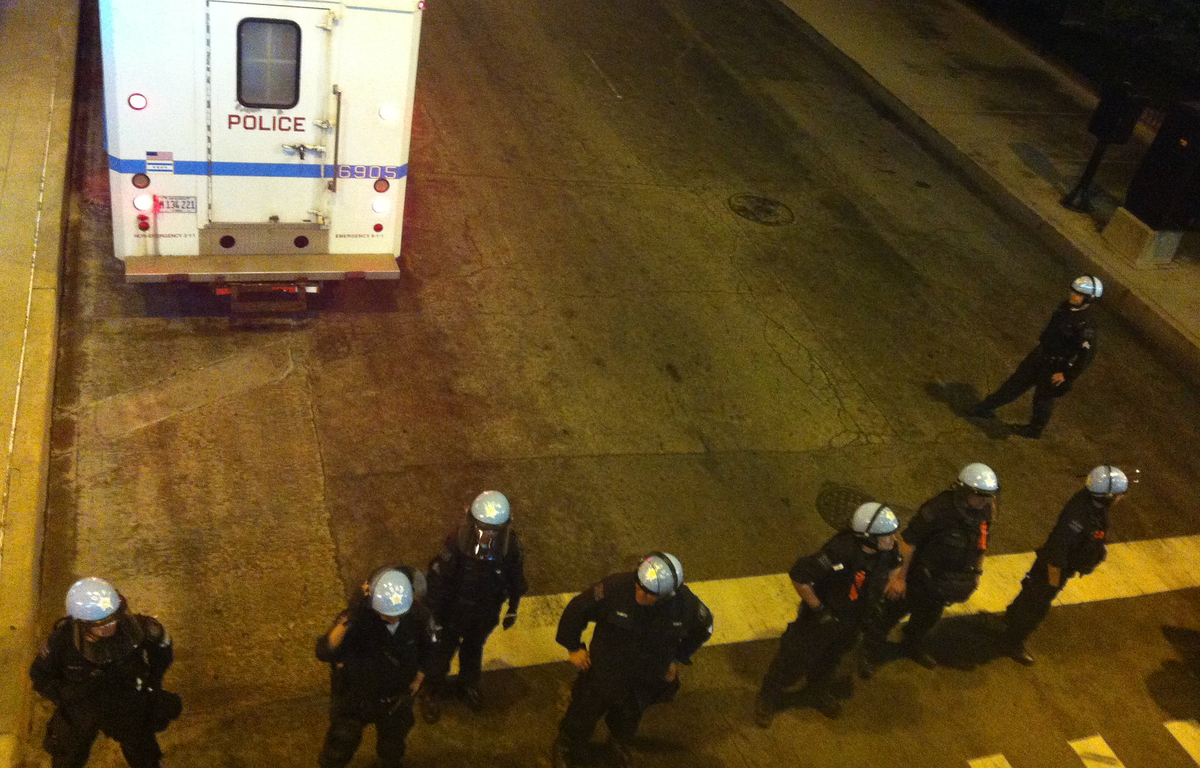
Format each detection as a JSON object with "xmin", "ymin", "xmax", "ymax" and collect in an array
[{"xmin": 317, "ymin": 599, "xmax": 433, "ymax": 702}]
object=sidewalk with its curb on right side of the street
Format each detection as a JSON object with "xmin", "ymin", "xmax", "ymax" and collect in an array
[{"xmin": 782, "ymin": 0, "xmax": 1200, "ymax": 383}]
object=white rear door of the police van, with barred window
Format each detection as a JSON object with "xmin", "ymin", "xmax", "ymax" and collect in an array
[{"xmin": 200, "ymin": 0, "xmax": 334, "ymax": 254}]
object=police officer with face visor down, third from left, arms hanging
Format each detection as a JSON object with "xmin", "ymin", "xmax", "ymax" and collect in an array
[{"xmin": 421, "ymin": 491, "xmax": 529, "ymax": 722}]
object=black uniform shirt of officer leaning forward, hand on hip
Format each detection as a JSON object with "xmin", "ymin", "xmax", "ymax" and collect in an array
[{"xmin": 556, "ymin": 572, "xmax": 713, "ymax": 680}]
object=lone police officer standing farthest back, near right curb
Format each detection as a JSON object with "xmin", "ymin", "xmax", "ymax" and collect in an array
[{"xmin": 967, "ymin": 275, "xmax": 1104, "ymax": 439}]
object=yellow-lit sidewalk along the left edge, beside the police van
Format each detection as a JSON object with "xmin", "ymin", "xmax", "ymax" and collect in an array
[{"xmin": 0, "ymin": 0, "xmax": 79, "ymax": 768}]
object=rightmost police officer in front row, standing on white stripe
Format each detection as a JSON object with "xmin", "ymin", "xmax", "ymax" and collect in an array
[{"xmin": 1004, "ymin": 464, "xmax": 1129, "ymax": 666}]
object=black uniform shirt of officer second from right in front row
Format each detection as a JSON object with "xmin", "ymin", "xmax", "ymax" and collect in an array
[{"xmin": 902, "ymin": 491, "xmax": 996, "ymax": 575}]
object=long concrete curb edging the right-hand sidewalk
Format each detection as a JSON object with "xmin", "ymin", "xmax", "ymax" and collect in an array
[{"xmin": 785, "ymin": 4, "xmax": 1200, "ymax": 386}]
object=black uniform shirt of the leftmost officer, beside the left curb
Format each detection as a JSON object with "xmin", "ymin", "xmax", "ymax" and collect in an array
[{"xmin": 29, "ymin": 613, "xmax": 175, "ymax": 715}]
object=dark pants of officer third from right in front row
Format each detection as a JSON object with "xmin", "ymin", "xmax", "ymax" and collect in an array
[{"xmin": 758, "ymin": 606, "xmax": 859, "ymax": 706}]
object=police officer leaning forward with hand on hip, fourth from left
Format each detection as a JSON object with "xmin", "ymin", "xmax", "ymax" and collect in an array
[{"xmin": 554, "ymin": 552, "xmax": 713, "ymax": 768}]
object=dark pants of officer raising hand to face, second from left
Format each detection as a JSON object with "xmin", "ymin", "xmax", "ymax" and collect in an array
[{"xmin": 317, "ymin": 692, "xmax": 416, "ymax": 768}]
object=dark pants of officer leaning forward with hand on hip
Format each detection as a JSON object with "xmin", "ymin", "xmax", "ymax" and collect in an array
[{"xmin": 558, "ymin": 670, "xmax": 661, "ymax": 746}]
